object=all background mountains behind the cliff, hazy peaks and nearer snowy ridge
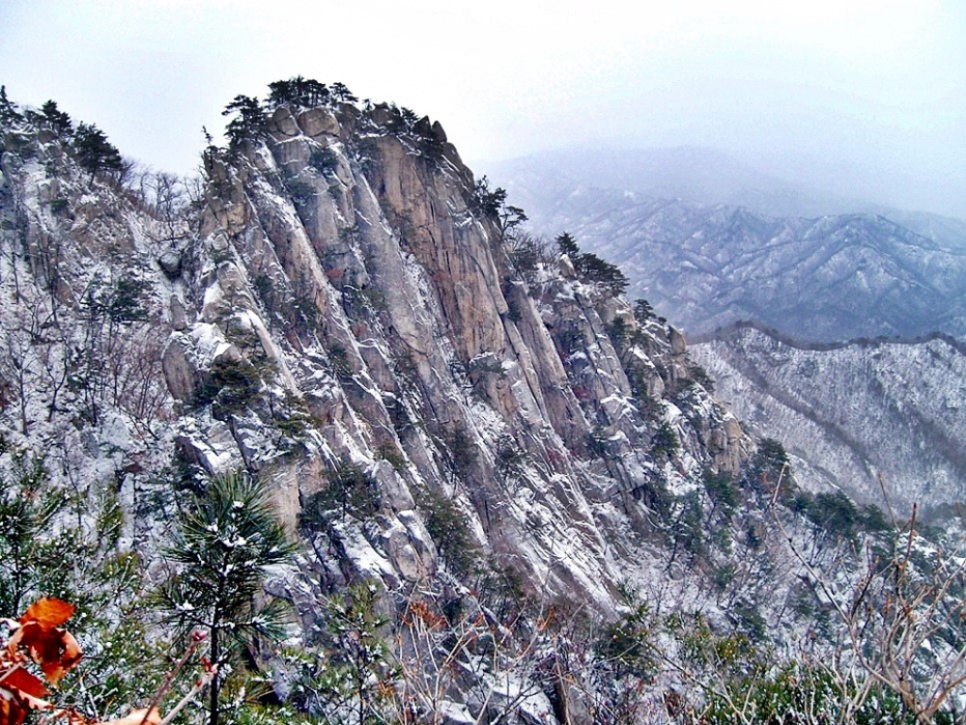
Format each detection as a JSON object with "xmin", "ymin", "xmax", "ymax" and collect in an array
[{"xmin": 494, "ymin": 148, "xmax": 966, "ymax": 506}]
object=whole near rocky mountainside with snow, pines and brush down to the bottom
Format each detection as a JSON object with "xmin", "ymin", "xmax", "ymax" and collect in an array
[{"xmin": 0, "ymin": 83, "xmax": 961, "ymax": 725}]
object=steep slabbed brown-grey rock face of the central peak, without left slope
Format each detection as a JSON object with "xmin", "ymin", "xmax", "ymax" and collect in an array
[{"xmin": 176, "ymin": 107, "xmax": 748, "ymax": 606}]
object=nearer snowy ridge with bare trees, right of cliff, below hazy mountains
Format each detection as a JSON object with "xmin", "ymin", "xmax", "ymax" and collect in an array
[{"xmin": 691, "ymin": 326, "xmax": 966, "ymax": 512}]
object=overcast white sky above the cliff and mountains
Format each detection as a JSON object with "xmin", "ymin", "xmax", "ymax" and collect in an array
[{"xmin": 0, "ymin": 0, "xmax": 966, "ymax": 218}]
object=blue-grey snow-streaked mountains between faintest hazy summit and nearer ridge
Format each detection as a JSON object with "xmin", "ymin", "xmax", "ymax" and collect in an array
[{"xmin": 488, "ymin": 151, "xmax": 966, "ymax": 341}]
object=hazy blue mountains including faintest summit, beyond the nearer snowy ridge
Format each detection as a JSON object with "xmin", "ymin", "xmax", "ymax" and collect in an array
[{"xmin": 494, "ymin": 148, "xmax": 966, "ymax": 341}]
